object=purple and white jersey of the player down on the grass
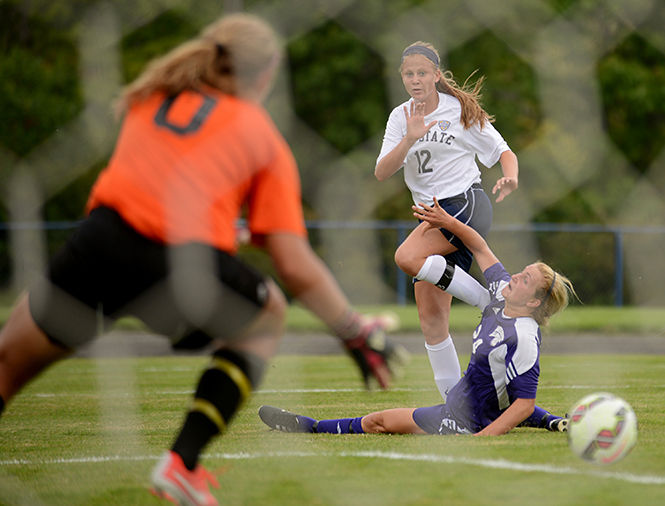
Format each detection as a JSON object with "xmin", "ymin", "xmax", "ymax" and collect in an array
[{"xmin": 446, "ymin": 263, "xmax": 540, "ymax": 432}]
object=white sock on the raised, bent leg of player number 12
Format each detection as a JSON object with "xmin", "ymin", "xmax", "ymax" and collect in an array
[{"xmin": 416, "ymin": 255, "xmax": 490, "ymax": 310}]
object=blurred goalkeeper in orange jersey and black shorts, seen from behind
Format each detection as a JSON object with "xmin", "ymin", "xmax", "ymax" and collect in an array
[{"xmin": 0, "ymin": 14, "xmax": 405, "ymax": 505}]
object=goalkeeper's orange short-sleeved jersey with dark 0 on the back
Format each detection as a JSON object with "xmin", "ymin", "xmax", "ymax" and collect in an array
[{"xmin": 87, "ymin": 91, "xmax": 306, "ymax": 252}]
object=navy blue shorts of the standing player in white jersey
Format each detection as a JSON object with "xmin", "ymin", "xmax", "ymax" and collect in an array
[{"xmin": 414, "ymin": 183, "xmax": 492, "ymax": 272}]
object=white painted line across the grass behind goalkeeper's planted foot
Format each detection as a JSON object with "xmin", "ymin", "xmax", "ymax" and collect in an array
[{"xmin": 0, "ymin": 451, "xmax": 665, "ymax": 485}]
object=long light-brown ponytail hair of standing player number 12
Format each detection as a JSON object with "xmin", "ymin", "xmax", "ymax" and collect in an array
[{"xmin": 400, "ymin": 40, "xmax": 494, "ymax": 129}]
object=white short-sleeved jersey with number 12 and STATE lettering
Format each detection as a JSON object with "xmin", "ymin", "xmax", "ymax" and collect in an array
[{"xmin": 377, "ymin": 92, "xmax": 510, "ymax": 204}]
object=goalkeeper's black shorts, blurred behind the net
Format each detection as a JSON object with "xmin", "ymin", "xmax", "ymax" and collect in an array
[{"xmin": 30, "ymin": 207, "xmax": 268, "ymax": 348}]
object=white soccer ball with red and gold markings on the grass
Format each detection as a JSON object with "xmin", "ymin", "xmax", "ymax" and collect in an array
[{"xmin": 568, "ymin": 392, "xmax": 637, "ymax": 464}]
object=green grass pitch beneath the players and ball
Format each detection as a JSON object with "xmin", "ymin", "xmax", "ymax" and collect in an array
[{"xmin": 0, "ymin": 354, "xmax": 665, "ymax": 506}]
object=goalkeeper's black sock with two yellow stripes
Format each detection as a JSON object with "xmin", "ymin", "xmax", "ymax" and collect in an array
[{"xmin": 171, "ymin": 349, "xmax": 265, "ymax": 470}]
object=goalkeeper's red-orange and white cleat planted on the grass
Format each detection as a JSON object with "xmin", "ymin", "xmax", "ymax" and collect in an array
[{"xmin": 151, "ymin": 451, "xmax": 219, "ymax": 506}]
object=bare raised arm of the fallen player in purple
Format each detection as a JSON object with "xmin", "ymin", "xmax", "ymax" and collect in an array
[{"xmin": 412, "ymin": 197, "xmax": 499, "ymax": 271}]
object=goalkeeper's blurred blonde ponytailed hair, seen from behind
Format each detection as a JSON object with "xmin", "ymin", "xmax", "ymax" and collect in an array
[{"xmin": 116, "ymin": 13, "xmax": 281, "ymax": 114}]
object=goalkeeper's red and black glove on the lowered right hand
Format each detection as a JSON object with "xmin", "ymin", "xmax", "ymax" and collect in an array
[{"xmin": 343, "ymin": 318, "xmax": 409, "ymax": 389}]
